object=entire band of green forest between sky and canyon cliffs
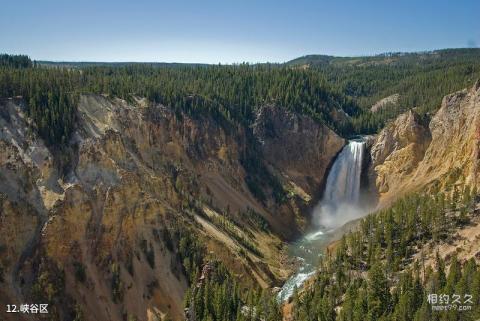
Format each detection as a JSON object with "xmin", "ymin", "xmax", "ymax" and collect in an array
[{"xmin": 0, "ymin": 49, "xmax": 480, "ymax": 148}]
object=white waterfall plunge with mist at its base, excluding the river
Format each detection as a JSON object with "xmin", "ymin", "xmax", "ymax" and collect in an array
[{"xmin": 313, "ymin": 140, "xmax": 365, "ymax": 229}]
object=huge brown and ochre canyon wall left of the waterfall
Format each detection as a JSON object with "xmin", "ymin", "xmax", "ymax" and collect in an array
[{"xmin": 0, "ymin": 95, "xmax": 343, "ymax": 320}]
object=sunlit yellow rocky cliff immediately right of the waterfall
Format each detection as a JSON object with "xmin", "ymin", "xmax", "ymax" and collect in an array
[{"xmin": 370, "ymin": 82, "xmax": 480, "ymax": 202}]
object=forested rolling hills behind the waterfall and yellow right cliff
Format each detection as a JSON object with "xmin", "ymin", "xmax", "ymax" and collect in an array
[{"xmin": 288, "ymin": 48, "xmax": 480, "ymax": 133}]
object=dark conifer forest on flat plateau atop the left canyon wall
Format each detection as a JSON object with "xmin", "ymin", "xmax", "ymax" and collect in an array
[{"xmin": 0, "ymin": 56, "xmax": 359, "ymax": 145}]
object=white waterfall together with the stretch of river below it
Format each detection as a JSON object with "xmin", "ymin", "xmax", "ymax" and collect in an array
[{"xmin": 278, "ymin": 140, "xmax": 370, "ymax": 301}]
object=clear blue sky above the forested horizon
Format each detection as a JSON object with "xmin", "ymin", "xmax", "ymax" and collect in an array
[{"xmin": 0, "ymin": 0, "xmax": 480, "ymax": 64}]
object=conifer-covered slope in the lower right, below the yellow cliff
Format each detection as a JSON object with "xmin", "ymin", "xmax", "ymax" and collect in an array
[{"xmin": 293, "ymin": 186, "xmax": 480, "ymax": 321}]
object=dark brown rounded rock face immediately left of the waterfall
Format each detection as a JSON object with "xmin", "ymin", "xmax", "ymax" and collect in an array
[{"xmin": 254, "ymin": 106, "xmax": 345, "ymax": 195}]
